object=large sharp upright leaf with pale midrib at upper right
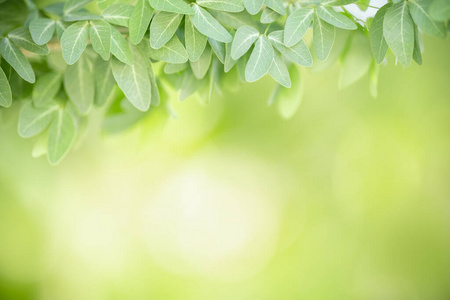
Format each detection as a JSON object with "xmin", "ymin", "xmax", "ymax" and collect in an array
[{"xmin": 383, "ymin": 1, "xmax": 414, "ymax": 66}]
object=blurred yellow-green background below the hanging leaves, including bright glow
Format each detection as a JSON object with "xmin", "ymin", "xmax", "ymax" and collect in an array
[{"xmin": 0, "ymin": 30, "xmax": 450, "ymax": 300}]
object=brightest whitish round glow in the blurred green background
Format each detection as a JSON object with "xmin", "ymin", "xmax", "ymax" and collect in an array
[{"xmin": 145, "ymin": 163, "xmax": 279, "ymax": 278}]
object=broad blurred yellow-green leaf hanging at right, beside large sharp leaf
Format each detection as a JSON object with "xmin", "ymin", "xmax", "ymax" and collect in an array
[{"xmin": 339, "ymin": 32, "xmax": 373, "ymax": 89}]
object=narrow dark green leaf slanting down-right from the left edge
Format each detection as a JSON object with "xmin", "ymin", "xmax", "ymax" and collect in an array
[{"xmin": 0, "ymin": 37, "xmax": 36, "ymax": 83}]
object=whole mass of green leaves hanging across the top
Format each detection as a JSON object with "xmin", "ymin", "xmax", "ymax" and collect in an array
[{"xmin": 0, "ymin": 0, "xmax": 450, "ymax": 164}]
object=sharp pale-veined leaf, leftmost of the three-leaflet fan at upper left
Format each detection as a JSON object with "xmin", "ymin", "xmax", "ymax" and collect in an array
[{"xmin": 61, "ymin": 21, "xmax": 89, "ymax": 65}]
